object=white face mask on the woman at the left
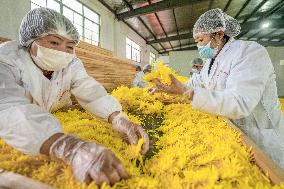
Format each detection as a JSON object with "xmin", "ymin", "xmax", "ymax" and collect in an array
[{"xmin": 31, "ymin": 43, "xmax": 75, "ymax": 71}]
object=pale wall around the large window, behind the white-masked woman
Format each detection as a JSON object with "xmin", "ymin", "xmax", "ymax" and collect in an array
[{"xmin": 0, "ymin": 0, "xmax": 157, "ymax": 66}]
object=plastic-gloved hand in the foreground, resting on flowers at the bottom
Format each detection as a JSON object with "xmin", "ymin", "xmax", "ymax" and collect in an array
[{"xmin": 49, "ymin": 135, "xmax": 128, "ymax": 187}]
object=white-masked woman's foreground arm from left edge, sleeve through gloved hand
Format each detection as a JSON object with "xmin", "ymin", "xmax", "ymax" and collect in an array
[{"xmin": 0, "ymin": 63, "xmax": 127, "ymax": 186}]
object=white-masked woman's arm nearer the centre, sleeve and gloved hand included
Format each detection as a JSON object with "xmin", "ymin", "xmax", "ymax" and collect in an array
[{"xmin": 71, "ymin": 59, "xmax": 149, "ymax": 154}]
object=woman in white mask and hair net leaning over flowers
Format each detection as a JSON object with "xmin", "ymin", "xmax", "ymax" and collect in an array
[{"xmin": 0, "ymin": 8, "xmax": 149, "ymax": 185}]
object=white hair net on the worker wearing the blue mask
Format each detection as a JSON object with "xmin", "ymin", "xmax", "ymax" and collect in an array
[{"xmin": 193, "ymin": 8, "xmax": 241, "ymax": 38}]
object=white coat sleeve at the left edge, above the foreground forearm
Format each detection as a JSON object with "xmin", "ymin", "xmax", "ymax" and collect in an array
[{"xmin": 0, "ymin": 61, "xmax": 62, "ymax": 154}]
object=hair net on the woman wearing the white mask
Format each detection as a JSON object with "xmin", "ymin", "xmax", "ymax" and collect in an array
[{"xmin": 19, "ymin": 8, "xmax": 79, "ymax": 47}]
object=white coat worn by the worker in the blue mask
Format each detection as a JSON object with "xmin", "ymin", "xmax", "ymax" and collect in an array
[{"xmin": 187, "ymin": 39, "xmax": 284, "ymax": 169}]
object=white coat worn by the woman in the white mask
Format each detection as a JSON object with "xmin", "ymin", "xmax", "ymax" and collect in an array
[{"xmin": 0, "ymin": 41, "xmax": 121, "ymax": 154}]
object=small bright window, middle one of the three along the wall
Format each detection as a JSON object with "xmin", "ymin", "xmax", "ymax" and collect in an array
[{"xmin": 126, "ymin": 37, "xmax": 141, "ymax": 62}]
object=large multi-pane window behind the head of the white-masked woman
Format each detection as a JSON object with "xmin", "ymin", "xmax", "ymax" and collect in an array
[{"xmin": 31, "ymin": 0, "xmax": 100, "ymax": 46}]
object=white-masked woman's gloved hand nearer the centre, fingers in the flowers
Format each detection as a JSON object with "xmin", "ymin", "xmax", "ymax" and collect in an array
[{"xmin": 111, "ymin": 112, "xmax": 149, "ymax": 154}]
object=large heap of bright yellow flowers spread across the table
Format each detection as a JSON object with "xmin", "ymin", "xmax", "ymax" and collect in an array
[{"xmin": 0, "ymin": 64, "xmax": 284, "ymax": 189}]
